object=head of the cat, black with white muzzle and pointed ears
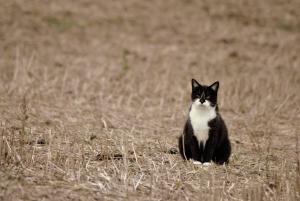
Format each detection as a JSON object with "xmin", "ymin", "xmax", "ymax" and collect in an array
[{"xmin": 192, "ymin": 79, "xmax": 219, "ymax": 108}]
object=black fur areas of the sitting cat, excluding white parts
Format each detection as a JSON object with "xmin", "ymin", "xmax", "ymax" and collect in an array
[{"xmin": 179, "ymin": 79, "xmax": 231, "ymax": 164}]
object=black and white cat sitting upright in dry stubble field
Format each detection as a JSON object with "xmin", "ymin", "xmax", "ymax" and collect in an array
[{"xmin": 179, "ymin": 79, "xmax": 231, "ymax": 165}]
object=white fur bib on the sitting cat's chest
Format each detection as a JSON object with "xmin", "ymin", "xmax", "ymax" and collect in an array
[{"xmin": 189, "ymin": 104, "xmax": 216, "ymax": 146}]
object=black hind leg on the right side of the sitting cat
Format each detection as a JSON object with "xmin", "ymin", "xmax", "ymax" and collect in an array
[{"xmin": 214, "ymin": 138, "xmax": 231, "ymax": 165}]
